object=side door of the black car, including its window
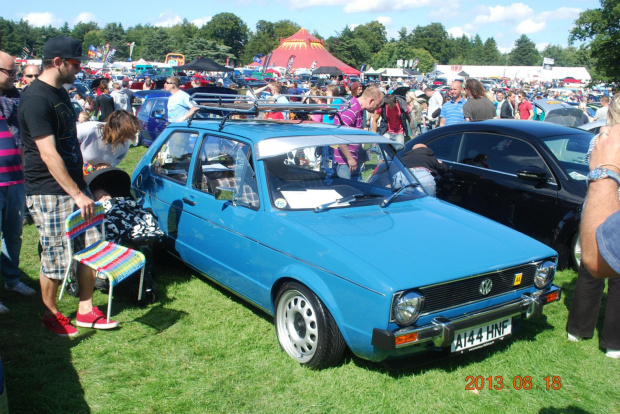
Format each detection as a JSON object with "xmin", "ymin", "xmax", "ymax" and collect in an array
[{"xmin": 429, "ymin": 132, "xmax": 559, "ymax": 244}]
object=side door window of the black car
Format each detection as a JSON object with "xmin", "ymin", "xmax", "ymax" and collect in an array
[{"xmin": 460, "ymin": 134, "xmax": 548, "ymax": 175}]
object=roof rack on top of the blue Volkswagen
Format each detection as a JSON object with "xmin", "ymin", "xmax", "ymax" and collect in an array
[{"xmin": 187, "ymin": 92, "xmax": 351, "ymax": 130}]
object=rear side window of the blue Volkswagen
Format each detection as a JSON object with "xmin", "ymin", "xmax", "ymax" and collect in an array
[{"xmin": 152, "ymin": 131, "xmax": 198, "ymax": 184}]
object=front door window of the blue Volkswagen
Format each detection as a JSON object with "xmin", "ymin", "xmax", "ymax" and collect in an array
[{"xmin": 192, "ymin": 135, "xmax": 260, "ymax": 209}]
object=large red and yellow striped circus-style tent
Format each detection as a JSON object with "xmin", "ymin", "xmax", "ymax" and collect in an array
[{"xmin": 269, "ymin": 28, "xmax": 360, "ymax": 75}]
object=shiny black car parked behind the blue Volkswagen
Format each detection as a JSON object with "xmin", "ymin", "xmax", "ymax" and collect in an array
[{"xmin": 399, "ymin": 119, "xmax": 593, "ymax": 268}]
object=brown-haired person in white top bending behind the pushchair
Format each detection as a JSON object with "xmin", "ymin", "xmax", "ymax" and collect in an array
[{"xmin": 77, "ymin": 110, "xmax": 140, "ymax": 170}]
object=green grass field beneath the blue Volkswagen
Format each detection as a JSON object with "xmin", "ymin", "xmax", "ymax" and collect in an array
[{"xmin": 0, "ymin": 148, "xmax": 620, "ymax": 413}]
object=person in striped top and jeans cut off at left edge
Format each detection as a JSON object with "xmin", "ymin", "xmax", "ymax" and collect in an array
[{"xmin": 0, "ymin": 52, "xmax": 35, "ymax": 313}]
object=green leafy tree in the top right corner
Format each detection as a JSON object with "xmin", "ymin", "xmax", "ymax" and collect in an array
[{"xmin": 568, "ymin": 0, "xmax": 620, "ymax": 82}]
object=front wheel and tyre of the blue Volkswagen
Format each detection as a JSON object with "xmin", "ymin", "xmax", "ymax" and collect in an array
[{"xmin": 275, "ymin": 282, "xmax": 346, "ymax": 369}]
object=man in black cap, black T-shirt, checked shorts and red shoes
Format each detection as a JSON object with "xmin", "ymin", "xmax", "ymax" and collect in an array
[{"xmin": 19, "ymin": 36, "xmax": 118, "ymax": 337}]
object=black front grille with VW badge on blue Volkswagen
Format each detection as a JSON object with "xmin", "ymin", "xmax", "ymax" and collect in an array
[{"xmin": 418, "ymin": 262, "xmax": 540, "ymax": 315}]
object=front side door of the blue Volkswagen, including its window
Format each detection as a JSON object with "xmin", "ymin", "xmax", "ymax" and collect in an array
[{"xmin": 182, "ymin": 133, "xmax": 268, "ymax": 302}]
